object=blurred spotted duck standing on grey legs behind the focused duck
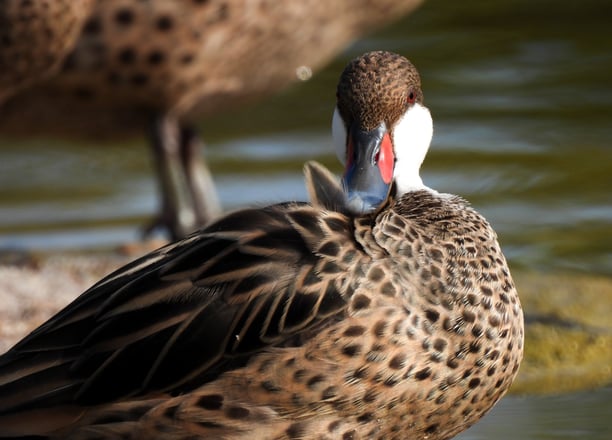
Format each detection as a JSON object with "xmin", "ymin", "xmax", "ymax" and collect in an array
[{"xmin": 0, "ymin": 0, "xmax": 422, "ymax": 239}]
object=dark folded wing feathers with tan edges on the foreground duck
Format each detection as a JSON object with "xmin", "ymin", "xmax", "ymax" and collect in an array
[{"xmin": 0, "ymin": 203, "xmax": 352, "ymax": 414}]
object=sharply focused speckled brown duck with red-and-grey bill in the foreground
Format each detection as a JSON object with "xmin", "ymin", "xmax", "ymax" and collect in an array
[{"xmin": 0, "ymin": 52, "xmax": 523, "ymax": 440}]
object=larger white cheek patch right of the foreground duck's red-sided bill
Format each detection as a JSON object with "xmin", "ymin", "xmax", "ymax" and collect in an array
[{"xmin": 393, "ymin": 103, "xmax": 433, "ymax": 194}]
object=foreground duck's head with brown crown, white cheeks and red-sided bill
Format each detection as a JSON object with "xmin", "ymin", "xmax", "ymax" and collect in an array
[{"xmin": 332, "ymin": 51, "xmax": 433, "ymax": 214}]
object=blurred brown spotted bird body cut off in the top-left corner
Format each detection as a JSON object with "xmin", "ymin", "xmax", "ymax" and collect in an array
[{"xmin": 0, "ymin": 0, "xmax": 93, "ymax": 103}]
